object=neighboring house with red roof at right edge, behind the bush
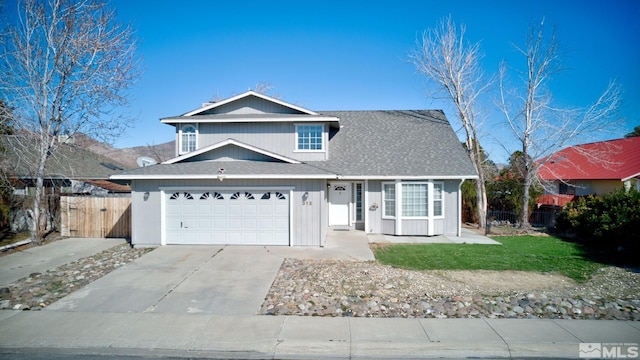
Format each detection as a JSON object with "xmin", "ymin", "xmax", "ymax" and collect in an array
[{"xmin": 538, "ymin": 137, "xmax": 640, "ymax": 206}]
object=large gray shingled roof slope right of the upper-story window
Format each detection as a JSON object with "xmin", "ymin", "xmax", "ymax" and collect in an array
[{"xmin": 310, "ymin": 110, "xmax": 477, "ymax": 177}]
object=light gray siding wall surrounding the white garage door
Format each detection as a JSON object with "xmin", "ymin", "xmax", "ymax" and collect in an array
[{"xmin": 131, "ymin": 179, "xmax": 327, "ymax": 247}]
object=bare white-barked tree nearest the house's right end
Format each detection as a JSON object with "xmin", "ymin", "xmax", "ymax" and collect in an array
[{"xmin": 410, "ymin": 17, "xmax": 491, "ymax": 228}]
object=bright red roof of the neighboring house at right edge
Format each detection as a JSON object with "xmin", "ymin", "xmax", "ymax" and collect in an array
[{"xmin": 538, "ymin": 137, "xmax": 640, "ymax": 181}]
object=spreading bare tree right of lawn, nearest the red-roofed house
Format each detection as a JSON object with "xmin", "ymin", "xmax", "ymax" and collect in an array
[{"xmin": 499, "ymin": 20, "xmax": 621, "ymax": 228}]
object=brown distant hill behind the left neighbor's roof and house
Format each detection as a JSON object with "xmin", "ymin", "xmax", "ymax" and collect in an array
[{"xmin": 73, "ymin": 134, "xmax": 176, "ymax": 169}]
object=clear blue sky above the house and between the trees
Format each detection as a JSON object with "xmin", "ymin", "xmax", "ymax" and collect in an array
[{"xmin": 85, "ymin": 0, "xmax": 640, "ymax": 161}]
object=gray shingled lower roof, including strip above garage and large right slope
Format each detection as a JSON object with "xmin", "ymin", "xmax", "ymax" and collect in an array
[{"xmin": 114, "ymin": 110, "xmax": 477, "ymax": 179}]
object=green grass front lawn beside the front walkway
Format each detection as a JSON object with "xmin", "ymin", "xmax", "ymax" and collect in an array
[{"xmin": 374, "ymin": 236, "xmax": 603, "ymax": 281}]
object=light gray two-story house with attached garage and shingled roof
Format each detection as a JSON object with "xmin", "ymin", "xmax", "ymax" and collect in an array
[{"xmin": 112, "ymin": 91, "xmax": 477, "ymax": 246}]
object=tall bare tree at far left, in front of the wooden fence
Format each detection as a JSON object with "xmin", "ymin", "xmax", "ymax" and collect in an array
[{"xmin": 0, "ymin": 0, "xmax": 140, "ymax": 243}]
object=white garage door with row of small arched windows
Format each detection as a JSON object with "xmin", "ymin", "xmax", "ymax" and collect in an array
[{"xmin": 165, "ymin": 190, "xmax": 289, "ymax": 245}]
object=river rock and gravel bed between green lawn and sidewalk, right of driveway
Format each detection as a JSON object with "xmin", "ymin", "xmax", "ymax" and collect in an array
[{"xmin": 259, "ymin": 259, "xmax": 640, "ymax": 321}]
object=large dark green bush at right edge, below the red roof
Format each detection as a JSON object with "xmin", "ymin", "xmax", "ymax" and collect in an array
[{"xmin": 556, "ymin": 188, "xmax": 640, "ymax": 250}]
